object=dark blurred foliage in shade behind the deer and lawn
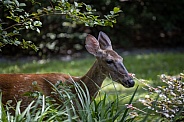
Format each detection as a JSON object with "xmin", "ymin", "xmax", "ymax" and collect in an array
[{"xmin": 0, "ymin": 0, "xmax": 184, "ymax": 58}]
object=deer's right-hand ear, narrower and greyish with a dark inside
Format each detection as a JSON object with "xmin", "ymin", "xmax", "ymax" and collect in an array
[{"xmin": 98, "ymin": 31, "xmax": 112, "ymax": 50}]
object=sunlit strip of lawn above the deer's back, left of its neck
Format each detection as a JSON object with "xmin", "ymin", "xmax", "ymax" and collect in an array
[{"xmin": 0, "ymin": 58, "xmax": 93, "ymax": 76}]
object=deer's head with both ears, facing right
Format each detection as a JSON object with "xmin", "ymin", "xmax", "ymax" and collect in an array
[{"xmin": 85, "ymin": 32, "xmax": 135, "ymax": 88}]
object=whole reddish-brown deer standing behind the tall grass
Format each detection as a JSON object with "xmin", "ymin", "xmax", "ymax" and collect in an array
[{"xmin": 0, "ymin": 32, "xmax": 134, "ymax": 106}]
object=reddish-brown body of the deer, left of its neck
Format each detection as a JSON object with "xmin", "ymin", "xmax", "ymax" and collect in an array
[{"xmin": 0, "ymin": 73, "xmax": 78, "ymax": 106}]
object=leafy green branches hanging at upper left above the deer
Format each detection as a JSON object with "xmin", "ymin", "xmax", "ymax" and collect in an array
[{"xmin": 0, "ymin": 0, "xmax": 121, "ymax": 51}]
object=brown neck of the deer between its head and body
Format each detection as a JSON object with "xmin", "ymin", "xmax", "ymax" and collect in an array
[{"xmin": 80, "ymin": 60, "xmax": 106, "ymax": 97}]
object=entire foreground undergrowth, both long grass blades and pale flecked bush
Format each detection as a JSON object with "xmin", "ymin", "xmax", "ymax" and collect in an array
[{"xmin": 0, "ymin": 73, "xmax": 184, "ymax": 122}]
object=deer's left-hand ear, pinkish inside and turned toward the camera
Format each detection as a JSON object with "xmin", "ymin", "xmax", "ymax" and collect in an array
[{"xmin": 85, "ymin": 34, "xmax": 100, "ymax": 56}]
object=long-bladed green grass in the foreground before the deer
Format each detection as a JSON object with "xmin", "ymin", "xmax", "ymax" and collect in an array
[{"xmin": 0, "ymin": 78, "xmax": 147, "ymax": 122}]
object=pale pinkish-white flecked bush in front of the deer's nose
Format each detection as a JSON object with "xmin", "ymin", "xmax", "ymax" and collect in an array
[{"xmin": 139, "ymin": 73, "xmax": 184, "ymax": 121}]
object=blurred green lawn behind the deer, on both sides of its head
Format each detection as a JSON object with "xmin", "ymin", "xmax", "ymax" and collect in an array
[{"xmin": 0, "ymin": 53, "xmax": 184, "ymax": 80}]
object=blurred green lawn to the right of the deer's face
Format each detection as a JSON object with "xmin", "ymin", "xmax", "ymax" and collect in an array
[{"xmin": 124, "ymin": 53, "xmax": 184, "ymax": 80}]
